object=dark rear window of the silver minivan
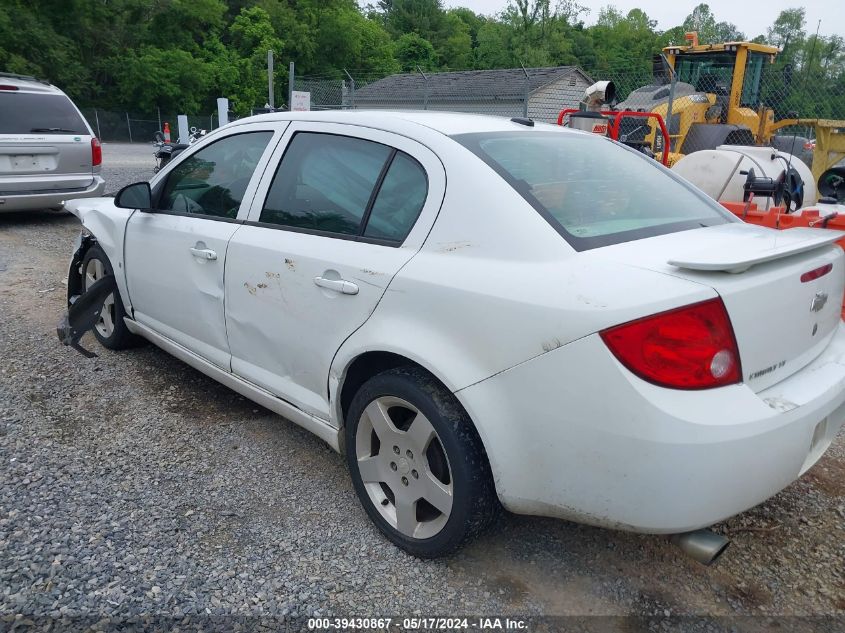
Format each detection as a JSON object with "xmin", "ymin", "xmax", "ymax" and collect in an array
[{"xmin": 0, "ymin": 90, "xmax": 89, "ymax": 134}]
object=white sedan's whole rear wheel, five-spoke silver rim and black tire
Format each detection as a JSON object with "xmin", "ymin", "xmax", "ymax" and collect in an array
[{"xmin": 346, "ymin": 367, "xmax": 500, "ymax": 558}]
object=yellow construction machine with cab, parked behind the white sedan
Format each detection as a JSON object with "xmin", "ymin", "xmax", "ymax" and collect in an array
[{"xmin": 616, "ymin": 32, "xmax": 845, "ymax": 181}]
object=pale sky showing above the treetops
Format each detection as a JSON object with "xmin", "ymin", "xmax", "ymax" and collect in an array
[{"xmin": 443, "ymin": 0, "xmax": 845, "ymax": 39}]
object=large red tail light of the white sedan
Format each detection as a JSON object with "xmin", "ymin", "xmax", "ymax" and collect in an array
[{"xmin": 601, "ymin": 299, "xmax": 742, "ymax": 389}]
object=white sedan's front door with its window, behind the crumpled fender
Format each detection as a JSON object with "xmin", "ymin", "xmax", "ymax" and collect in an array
[{"xmin": 124, "ymin": 124, "xmax": 281, "ymax": 370}]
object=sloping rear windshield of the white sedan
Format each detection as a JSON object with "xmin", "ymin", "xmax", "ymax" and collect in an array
[{"xmin": 453, "ymin": 131, "xmax": 734, "ymax": 251}]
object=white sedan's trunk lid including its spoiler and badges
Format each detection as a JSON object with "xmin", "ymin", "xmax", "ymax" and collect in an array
[{"xmin": 604, "ymin": 223, "xmax": 845, "ymax": 391}]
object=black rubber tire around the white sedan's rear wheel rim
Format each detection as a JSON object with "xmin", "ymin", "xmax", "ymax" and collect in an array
[{"xmin": 345, "ymin": 367, "xmax": 501, "ymax": 558}]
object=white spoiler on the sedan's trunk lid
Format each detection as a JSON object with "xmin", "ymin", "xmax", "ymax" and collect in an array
[{"xmin": 667, "ymin": 227, "xmax": 845, "ymax": 273}]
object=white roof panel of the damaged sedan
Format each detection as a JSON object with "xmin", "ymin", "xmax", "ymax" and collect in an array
[{"xmin": 238, "ymin": 110, "xmax": 566, "ymax": 136}]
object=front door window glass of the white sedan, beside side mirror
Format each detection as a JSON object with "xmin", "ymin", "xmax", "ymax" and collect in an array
[{"xmin": 157, "ymin": 132, "xmax": 273, "ymax": 219}]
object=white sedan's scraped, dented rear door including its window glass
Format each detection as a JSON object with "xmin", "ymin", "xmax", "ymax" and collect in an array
[{"xmin": 226, "ymin": 122, "xmax": 446, "ymax": 420}]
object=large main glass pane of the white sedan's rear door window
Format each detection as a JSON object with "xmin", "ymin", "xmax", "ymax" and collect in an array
[{"xmin": 259, "ymin": 132, "xmax": 393, "ymax": 235}]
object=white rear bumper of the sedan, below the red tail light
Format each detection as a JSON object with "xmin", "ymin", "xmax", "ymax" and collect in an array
[{"xmin": 457, "ymin": 323, "xmax": 845, "ymax": 533}]
